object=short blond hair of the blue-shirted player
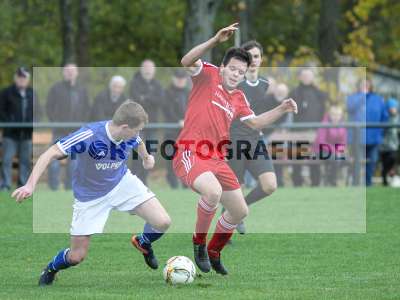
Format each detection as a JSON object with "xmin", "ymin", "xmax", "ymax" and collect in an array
[{"xmin": 112, "ymin": 100, "xmax": 149, "ymax": 128}]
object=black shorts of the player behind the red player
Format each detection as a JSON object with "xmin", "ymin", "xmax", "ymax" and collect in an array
[{"xmin": 228, "ymin": 137, "xmax": 275, "ymax": 183}]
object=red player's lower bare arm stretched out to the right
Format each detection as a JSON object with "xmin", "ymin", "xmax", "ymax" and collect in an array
[{"xmin": 243, "ymin": 98, "xmax": 297, "ymax": 129}]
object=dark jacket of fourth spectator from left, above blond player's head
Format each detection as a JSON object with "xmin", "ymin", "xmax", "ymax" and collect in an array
[{"xmin": 129, "ymin": 72, "xmax": 164, "ymax": 123}]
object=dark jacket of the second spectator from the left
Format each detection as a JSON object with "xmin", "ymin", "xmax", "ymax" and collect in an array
[{"xmin": 46, "ymin": 81, "xmax": 90, "ymax": 137}]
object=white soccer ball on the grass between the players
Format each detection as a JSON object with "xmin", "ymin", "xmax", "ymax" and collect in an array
[{"xmin": 163, "ymin": 256, "xmax": 196, "ymax": 284}]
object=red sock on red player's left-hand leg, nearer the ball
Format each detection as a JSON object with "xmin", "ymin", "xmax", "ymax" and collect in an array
[{"xmin": 193, "ymin": 197, "xmax": 217, "ymax": 244}]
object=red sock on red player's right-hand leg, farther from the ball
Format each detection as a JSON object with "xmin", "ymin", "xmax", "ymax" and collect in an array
[{"xmin": 207, "ymin": 215, "xmax": 236, "ymax": 258}]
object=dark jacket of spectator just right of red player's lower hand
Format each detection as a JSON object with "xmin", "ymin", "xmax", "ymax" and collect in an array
[{"xmin": 290, "ymin": 84, "xmax": 328, "ymax": 123}]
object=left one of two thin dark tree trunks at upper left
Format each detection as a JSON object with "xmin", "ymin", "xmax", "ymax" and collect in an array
[{"xmin": 60, "ymin": 0, "xmax": 75, "ymax": 65}]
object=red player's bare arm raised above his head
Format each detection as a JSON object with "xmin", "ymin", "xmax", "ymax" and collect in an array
[{"xmin": 181, "ymin": 23, "xmax": 239, "ymax": 68}]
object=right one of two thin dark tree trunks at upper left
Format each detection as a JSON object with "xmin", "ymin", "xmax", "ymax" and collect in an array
[{"xmin": 76, "ymin": 0, "xmax": 90, "ymax": 67}]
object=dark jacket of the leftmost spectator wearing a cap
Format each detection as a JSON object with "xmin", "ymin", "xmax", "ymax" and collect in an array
[{"xmin": 0, "ymin": 84, "xmax": 41, "ymax": 139}]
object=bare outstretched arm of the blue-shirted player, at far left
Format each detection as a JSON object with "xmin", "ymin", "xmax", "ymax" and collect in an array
[{"xmin": 11, "ymin": 145, "xmax": 65, "ymax": 203}]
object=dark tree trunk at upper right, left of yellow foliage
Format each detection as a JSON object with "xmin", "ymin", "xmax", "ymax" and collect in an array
[{"xmin": 318, "ymin": 0, "xmax": 340, "ymax": 65}]
